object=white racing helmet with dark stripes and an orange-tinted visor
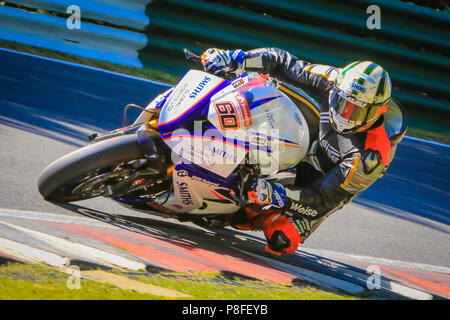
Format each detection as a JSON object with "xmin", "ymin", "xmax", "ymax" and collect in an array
[{"xmin": 329, "ymin": 61, "xmax": 391, "ymax": 134}]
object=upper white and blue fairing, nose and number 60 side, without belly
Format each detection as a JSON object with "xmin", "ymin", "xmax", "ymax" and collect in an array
[{"xmin": 158, "ymin": 71, "xmax": 309, "ymax": 177}]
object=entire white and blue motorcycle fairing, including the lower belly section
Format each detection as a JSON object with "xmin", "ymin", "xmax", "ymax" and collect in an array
[{"xmin": 158, "ymin": 71, "xmax": 309, "ymax": 214}]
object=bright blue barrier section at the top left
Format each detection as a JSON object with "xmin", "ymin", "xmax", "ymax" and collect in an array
[{"xmin": 0, "ymin": 0, "xmax": 150, "ymax": 67}]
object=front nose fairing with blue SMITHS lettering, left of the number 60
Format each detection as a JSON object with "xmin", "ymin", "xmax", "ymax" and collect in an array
[{"xmin": 158, "ymin": 70, "xmax": 247, "ymax": 177}]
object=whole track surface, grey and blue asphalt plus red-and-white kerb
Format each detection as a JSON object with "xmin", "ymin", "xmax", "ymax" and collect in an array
[{"xmin": 0, "ymin": 49, "xmax": 450, "ymax": 299}]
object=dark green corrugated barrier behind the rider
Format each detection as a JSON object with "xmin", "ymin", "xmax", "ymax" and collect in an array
[{"xmin": 140, "ymin": 0, "xmax": 450, "ymax": 133}]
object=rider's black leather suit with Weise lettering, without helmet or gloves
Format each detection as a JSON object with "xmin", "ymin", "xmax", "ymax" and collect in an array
[{"xmin": 243, "ymin": 48, "xmax": 392, "ymax": 242}]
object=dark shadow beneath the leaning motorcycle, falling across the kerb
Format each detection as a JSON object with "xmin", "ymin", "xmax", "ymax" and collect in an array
[{"xmin": 51, "ymin": 203, "xmax": 414, "ymax": 298}]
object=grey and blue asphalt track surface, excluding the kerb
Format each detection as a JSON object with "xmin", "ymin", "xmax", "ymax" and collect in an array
[{"xmin": 0, "ymin": 50, "xmax": 450, "ymax": 267}]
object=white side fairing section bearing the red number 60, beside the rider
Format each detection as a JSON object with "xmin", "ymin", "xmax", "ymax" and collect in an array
[{"xmin": 208, "ymin": 80, "xmax": 309, "ymax": 175}]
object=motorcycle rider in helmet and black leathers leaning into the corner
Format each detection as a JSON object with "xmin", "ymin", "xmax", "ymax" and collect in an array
[{"xmin": 201, "ymin": 48, "xmax": 400, "ymax": 254}]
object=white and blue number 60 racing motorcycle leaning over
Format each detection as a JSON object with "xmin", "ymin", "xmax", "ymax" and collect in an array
[{"xmin": 38, "ymin": 49, "xmax": 313, "ymax": 225}]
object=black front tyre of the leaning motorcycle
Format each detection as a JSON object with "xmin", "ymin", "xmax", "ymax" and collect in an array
[{"xmin": 38, "ymin": 134, "xmax": 144, "ymax": 202}]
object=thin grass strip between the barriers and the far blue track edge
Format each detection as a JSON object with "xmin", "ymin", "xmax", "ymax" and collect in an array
[{"xmin": 0, "ymin": 40, "xmax": 450, "ymax": 144}]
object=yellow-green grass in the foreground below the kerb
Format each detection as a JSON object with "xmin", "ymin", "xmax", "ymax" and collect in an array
[{"xmin": 0, "ymin": 263, "xmax": 355, "ymax": 300}]
